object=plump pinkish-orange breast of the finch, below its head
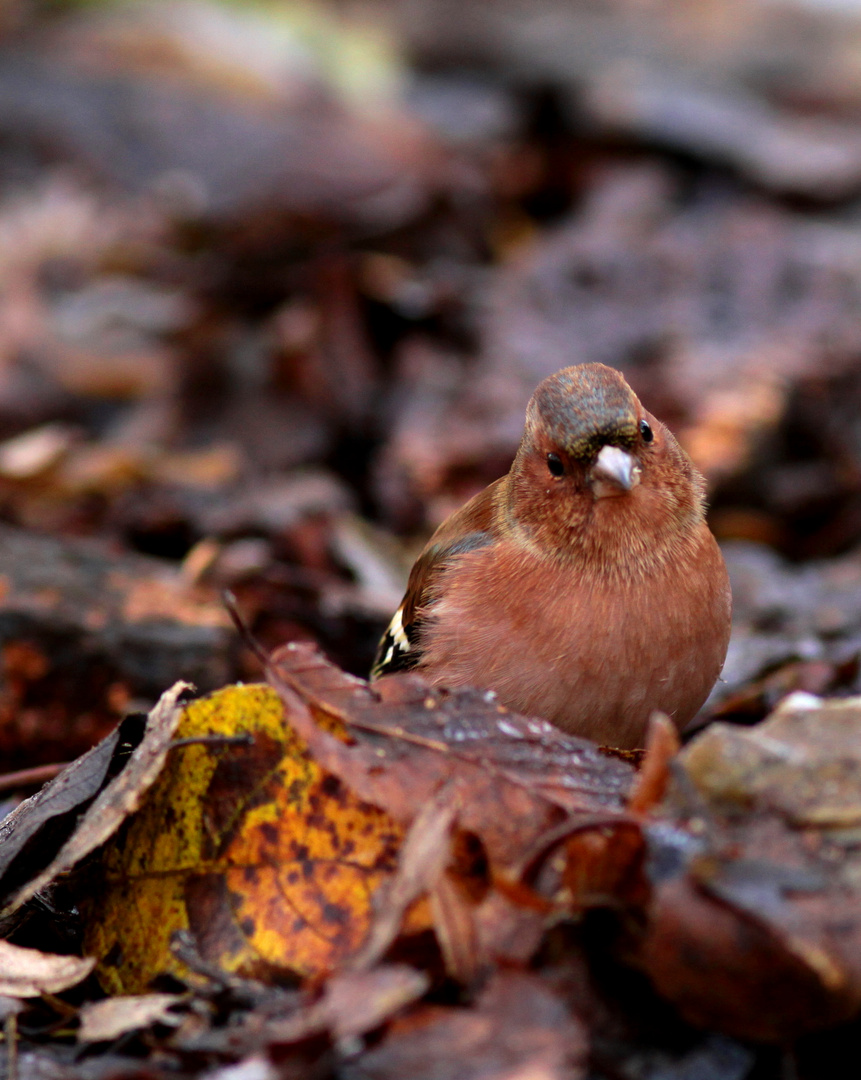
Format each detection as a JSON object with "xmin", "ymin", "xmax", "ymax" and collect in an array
[{"xmin": 412, "ymin": 526, "xmax": 729, "ymax": 746}]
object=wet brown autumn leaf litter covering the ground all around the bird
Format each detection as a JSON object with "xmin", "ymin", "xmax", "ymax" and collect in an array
[{"xmin": 0, "ymin": 0, "xmax": 861, "ymax": 1080}]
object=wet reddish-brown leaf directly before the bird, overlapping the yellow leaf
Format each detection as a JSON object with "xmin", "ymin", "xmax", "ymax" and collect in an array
[{"xmin": 269, "ymin": 643, "xmax": 634, "ymax": 865}]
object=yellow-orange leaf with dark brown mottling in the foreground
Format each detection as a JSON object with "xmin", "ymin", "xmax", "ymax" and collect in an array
[{"xmin": 85, "ymin": 686, "xmax": 402, "ymax": 994}]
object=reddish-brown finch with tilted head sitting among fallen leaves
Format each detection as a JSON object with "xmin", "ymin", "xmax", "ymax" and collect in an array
[{"xmin": 371, "ymin": 364, "xmax": 731, "ymax": 748}]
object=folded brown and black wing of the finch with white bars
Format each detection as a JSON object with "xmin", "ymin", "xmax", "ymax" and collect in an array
[{"xmin": 371, "ymin": 481, "xmax": 500, "ymax": 680}]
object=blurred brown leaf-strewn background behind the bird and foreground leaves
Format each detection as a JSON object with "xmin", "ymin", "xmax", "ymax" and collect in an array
[{"xmin": 0, "ymin": 0, "xmax": 861, "ymax": 769}]
